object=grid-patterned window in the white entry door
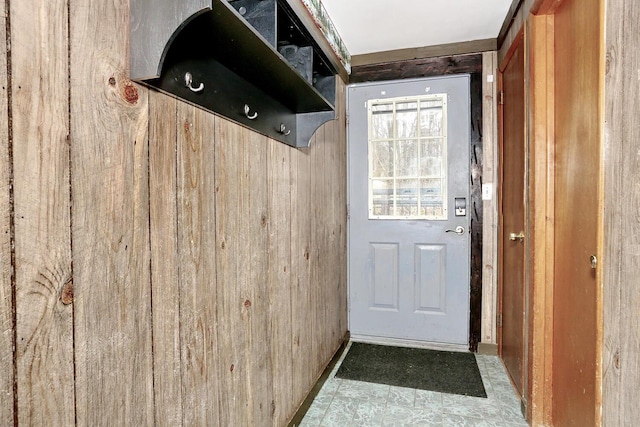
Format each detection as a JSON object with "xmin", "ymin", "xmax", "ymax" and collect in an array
[{"xmin": 368, "ymin": 94, "xmax": 447, "ymax": 220}]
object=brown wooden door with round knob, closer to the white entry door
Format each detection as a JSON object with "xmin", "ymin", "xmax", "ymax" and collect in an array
[{"xmin": 499, "ymin": 36, "xmax": 527, "ymax": 402}]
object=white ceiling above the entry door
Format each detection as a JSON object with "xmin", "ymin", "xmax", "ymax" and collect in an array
[{"xmin": 322, "ymin": 0, "xmax": 512, "ymax": 55}]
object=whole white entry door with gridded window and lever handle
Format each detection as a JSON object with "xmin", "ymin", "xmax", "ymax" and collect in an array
[{"xmin": 348, "ymin": 75, "xmax": 470, "ymax": 345}]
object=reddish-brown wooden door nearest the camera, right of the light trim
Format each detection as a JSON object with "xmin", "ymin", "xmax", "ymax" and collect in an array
[{"xmin": 552, "ymin": 0, "xmax": 602, "ymax": 426}]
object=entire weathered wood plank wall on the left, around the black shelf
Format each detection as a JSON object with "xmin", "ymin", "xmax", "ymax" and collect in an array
[{"xmin": 0, "ymin": 0, "xmax": 347, "ymax": 426}]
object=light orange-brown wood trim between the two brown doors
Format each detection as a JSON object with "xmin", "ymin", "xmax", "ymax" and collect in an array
[{"xmin": 527, "ymin": 15, "xmax": 555, "ymax": 425}]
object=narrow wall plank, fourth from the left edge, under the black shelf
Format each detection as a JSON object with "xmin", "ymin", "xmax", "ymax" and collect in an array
[{"xmin": 149, "ymin": 92, "xmax": 182, "ymax": 427}]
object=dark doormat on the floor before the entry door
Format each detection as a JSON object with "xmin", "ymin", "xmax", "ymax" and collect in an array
[{"xmin": 336, "ymin": 342, "xmax": 487, "ymax": 397}]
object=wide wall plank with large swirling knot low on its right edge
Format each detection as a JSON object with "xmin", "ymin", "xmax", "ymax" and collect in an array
[{"xmin": 9, "ymin": 0, "xmax": 75, "ymax": 425}]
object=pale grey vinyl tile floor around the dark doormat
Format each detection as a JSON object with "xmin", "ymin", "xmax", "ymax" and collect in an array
[{"xmin": 299, "ymin": 348, "xmax": 527, "ymax": 427}]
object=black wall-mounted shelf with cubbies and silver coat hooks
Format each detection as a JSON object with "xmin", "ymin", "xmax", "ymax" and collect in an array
[{"xmin": 131, "ymin": 0, "xmax": 337, "ymax": 147}]
